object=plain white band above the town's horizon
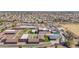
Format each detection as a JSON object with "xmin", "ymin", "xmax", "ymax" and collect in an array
[{"xmin": 0, "ymin": 0, "xmax": 79, "ymax": 11}]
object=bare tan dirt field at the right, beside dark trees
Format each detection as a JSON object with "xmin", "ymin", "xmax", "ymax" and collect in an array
[{"xmin": 61, "ymin": 23, "xmax": 79, "ymax": 36}]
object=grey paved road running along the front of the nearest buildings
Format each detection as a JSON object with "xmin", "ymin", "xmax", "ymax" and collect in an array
[{"xmin": 0, "ymin": 44, "xmax": 51, "ymax": 48}]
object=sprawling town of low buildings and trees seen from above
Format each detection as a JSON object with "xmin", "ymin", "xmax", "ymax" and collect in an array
[{"xmin": 0, "ymin": 11, "xmax": 79, "ymax": 48}]
